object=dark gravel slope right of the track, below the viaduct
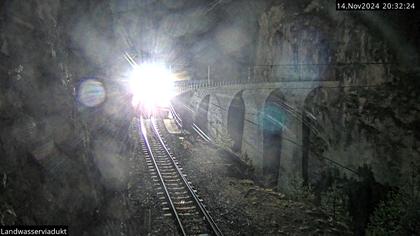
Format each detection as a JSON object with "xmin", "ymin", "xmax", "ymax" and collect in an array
[{"xmin": 159, "ymin": 120, "xmax": 350, "ymax": 235}]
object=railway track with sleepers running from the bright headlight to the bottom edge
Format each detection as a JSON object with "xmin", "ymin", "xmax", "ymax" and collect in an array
[{"xmin": 140, "ymin": 117, "xmax": 223, "ymax": 235}]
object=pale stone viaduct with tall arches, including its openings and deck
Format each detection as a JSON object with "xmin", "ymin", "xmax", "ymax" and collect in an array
[{"xmin": 175, "ymin": 81, "xmax": 339, "ymax": 192}]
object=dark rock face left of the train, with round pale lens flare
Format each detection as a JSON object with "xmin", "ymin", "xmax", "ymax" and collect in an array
[{"xmin": 0, "ymin": 0, "xmax": 130, "ymax": 232}]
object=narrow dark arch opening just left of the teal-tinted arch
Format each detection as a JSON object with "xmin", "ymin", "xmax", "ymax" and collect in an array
[{"xmin": 227, "ymin": 91, "xmax": 245, "ymax": 152}]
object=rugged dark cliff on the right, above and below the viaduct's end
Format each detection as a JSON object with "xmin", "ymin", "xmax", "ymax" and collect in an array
[{"xmin": 254, "ymin": 1, "xmax": 420, "ymax": 185}]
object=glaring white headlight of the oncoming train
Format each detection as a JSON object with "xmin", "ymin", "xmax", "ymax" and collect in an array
[{"xmin": 130, "ymin": 63, "xmax": 174, "ymax": 110}]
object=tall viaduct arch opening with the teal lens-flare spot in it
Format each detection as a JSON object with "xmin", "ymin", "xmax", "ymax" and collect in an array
[{"xmin": 262, "ymin": 90, "xmax": 286, "ymax": 187}]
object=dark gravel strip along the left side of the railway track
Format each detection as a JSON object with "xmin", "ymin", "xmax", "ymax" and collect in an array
[{"xmin": 89, "ymin": 118, "xmax": 178, "ymax": 236}]
